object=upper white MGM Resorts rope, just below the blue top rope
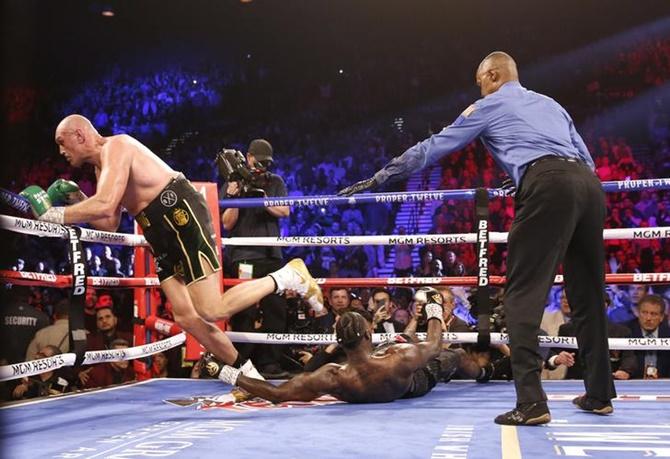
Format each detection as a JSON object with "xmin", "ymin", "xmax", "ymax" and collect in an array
[{"xmin": 0, "ymin": 215, "xmax": 670, "ymax": 247}]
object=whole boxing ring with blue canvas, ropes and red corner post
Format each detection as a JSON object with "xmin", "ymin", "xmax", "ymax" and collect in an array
[{"xmin": 0, "ymin": 179, "xmax": 670, "ymax": 458}]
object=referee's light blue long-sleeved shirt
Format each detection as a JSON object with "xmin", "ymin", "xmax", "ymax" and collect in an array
[{"xmin": 375, "ymin": 81, "xmax": 595, "ymax": 186}]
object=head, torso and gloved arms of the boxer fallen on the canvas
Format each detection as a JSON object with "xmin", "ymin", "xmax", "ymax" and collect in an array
[{"xmin": 219, "ymin": 289, "xmax": 442, "ymax": 403}]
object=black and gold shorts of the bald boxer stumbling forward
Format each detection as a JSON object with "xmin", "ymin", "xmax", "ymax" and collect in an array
[{"xmin": 135, "ymin": 174, "xmax": 221, "ymax": 285}]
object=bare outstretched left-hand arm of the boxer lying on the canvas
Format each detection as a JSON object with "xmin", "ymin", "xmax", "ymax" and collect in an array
[{"xmin": 237, "ymin": 363, "xmax": 340, "ymax": 403}]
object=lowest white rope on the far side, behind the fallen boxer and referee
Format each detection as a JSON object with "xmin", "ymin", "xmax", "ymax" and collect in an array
[{"xmin": 226, "ymin": 331, "xmax": 670, "ymax": 351}]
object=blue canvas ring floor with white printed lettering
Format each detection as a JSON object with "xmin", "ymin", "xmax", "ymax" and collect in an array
[{"xmin": 0, "ymin": 379, "xmax": 670, "ymax": 459}]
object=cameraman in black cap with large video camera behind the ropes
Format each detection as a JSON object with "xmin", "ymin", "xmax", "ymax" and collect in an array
[{"xmin": 218, "ymin": 139, "xmax": 290, "ymax": 378}]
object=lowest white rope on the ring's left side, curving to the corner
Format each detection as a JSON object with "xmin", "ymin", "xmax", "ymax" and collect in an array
[{"xmin": 0, "ymin": 333, "xmax": 186, "ymax": 381}]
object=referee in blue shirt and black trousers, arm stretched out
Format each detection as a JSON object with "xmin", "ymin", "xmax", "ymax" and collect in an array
[{"xmin": 340, "ymin": 51, "xmax": 616, "ymax": 425}]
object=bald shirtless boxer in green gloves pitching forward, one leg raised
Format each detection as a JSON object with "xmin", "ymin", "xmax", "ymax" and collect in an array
[{"xmin": 22, "ymin": 115, "xmax": 323, "ymax": 366}]
